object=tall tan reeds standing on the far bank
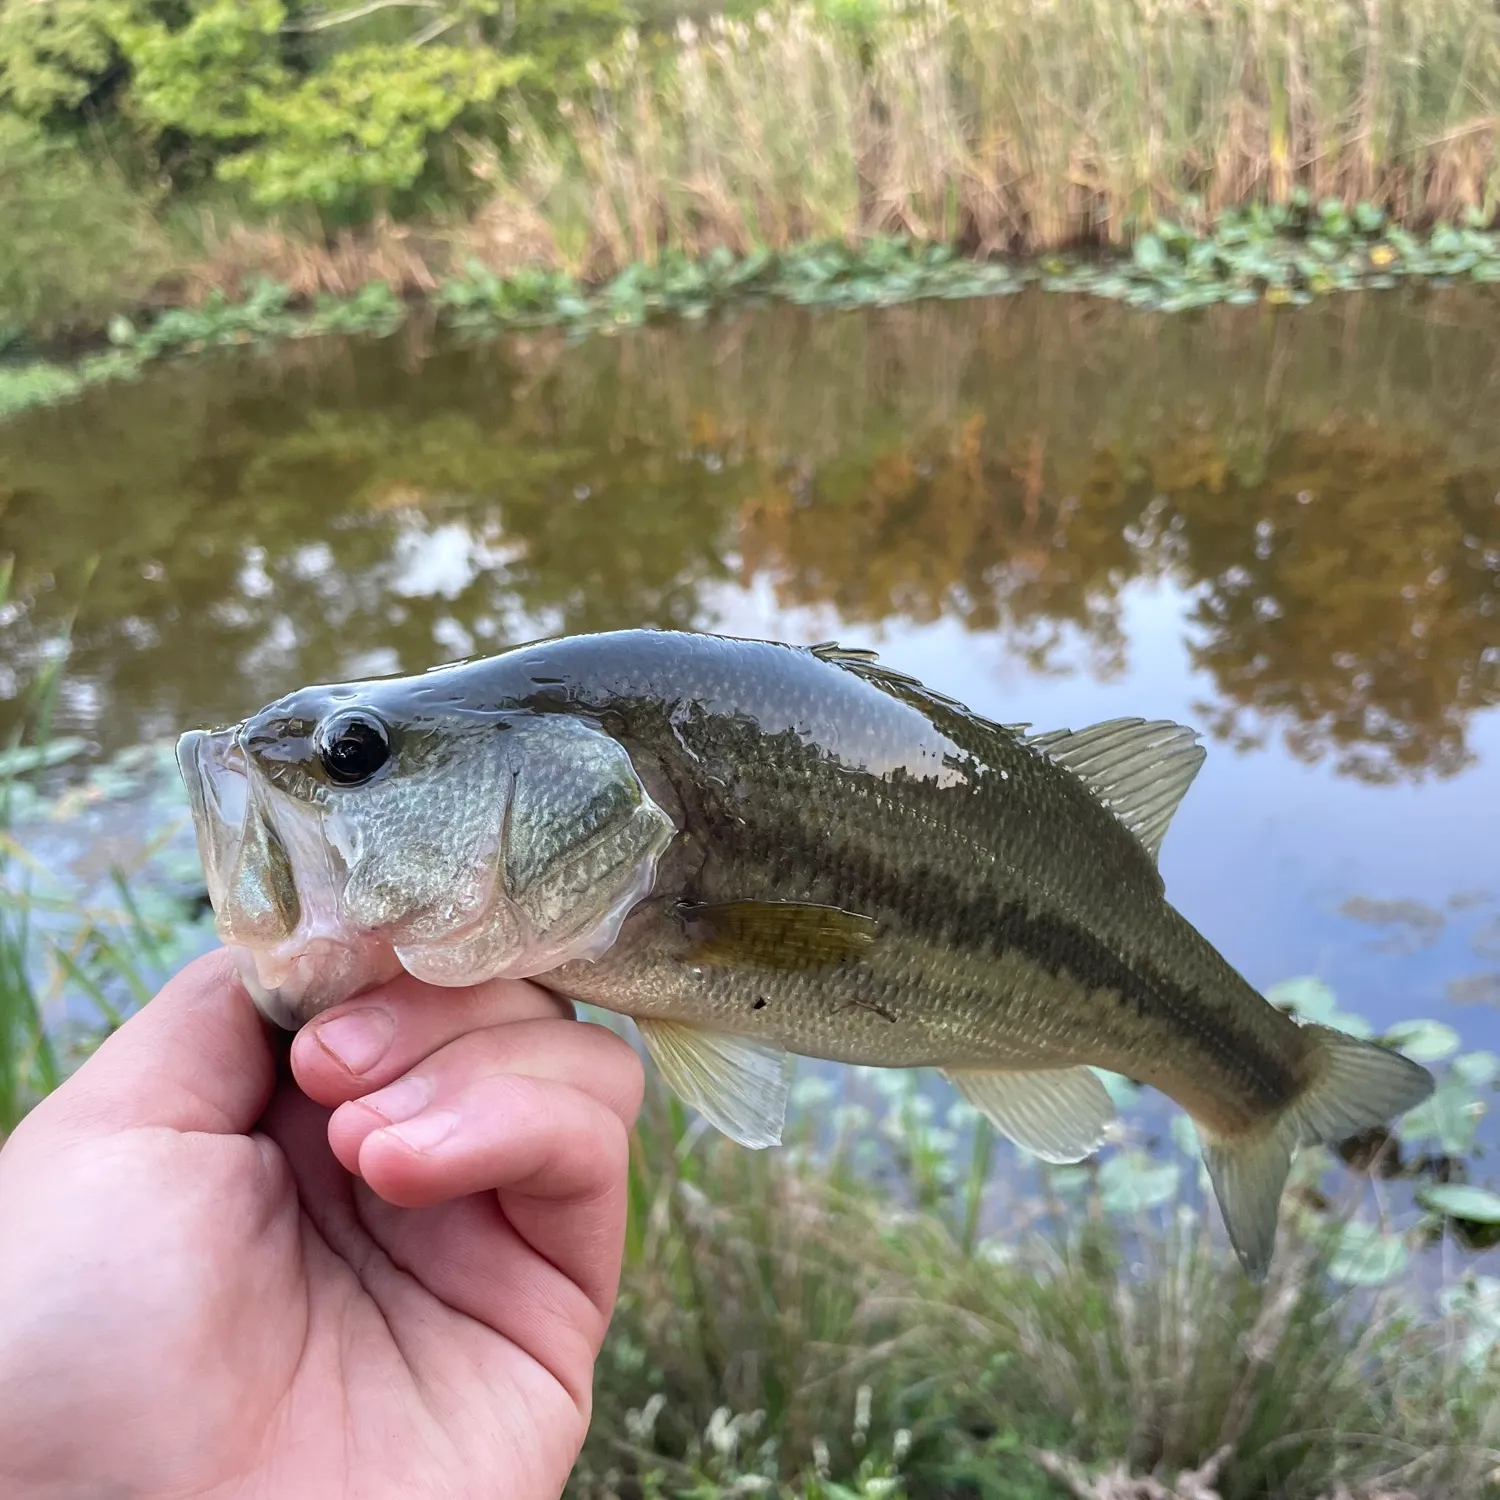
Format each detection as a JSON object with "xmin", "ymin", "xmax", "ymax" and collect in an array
[{"xmin": 492, "ymin": 0, "xmax": 1500, "ymax": 273}]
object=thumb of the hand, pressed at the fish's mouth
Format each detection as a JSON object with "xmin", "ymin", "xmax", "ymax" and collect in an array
[{"xmin": 33, "ymin": 948, "xmax": 276, "ymax": 1136}]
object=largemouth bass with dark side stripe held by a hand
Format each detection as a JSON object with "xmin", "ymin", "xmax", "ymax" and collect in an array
[{"xmin": 177, "ymin": 630, "xmax": 1434, "ymax": 1281}]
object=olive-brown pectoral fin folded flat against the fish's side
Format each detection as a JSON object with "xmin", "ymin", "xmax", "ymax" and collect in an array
[{"xmin": 678, "ymin": 902, "xmax": 881, "ymax": 969}]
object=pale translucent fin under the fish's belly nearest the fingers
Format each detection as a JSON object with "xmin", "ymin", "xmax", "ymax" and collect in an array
[{"xmin": 636, "ymin": 1020, "xmax": 792, "ymax": 1151}]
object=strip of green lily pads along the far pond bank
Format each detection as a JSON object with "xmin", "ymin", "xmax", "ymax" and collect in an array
[{"xmin": 0, "ymin": 208, "xmax": 1500, "ymax": 417}]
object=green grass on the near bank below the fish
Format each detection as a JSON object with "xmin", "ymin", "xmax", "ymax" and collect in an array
[{"xmin": 573, "ymin": 1092, "xmax": 1500, "ymax": 1500}]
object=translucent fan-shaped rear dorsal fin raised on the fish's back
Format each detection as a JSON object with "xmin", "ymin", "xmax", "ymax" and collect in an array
[{"xmin": 1028, "ymin": 719, "xmax": 1206, "ymax": 860}]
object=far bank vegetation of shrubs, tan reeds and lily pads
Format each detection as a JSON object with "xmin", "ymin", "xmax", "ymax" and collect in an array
[{"xmin": 0, "ymin": 0, "xmax": 1500, "ymax": 414}]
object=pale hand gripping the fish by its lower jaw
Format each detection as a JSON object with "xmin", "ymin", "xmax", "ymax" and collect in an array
[{"xmin": 0, "ymin": 953, "xmax": 642, "ymax": 1500}]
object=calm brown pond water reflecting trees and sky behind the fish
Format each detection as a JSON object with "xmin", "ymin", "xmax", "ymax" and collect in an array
[{"xmin": 0, "ymin": 290, "xmax": 1500, "ymax": 1049}]
